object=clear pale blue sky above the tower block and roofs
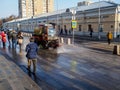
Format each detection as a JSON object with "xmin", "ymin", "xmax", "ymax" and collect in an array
[{"xmin": 0, "ymin": 0, "xmax": 120, "ymax": 18}]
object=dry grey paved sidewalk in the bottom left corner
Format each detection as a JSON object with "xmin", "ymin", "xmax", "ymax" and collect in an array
[{"xmin": 0, "ymin": 54, "xmax": 42, "ymax": 90}]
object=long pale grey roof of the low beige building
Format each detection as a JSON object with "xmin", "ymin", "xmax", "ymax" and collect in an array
[{"xmin": 4, "ymin": 1, "xmax": 119, "ymax": 22}]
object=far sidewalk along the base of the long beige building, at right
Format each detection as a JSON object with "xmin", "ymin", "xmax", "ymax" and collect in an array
[{"xmin": 60, "ymin": 35, "xmax": 120, "ymax": 54}]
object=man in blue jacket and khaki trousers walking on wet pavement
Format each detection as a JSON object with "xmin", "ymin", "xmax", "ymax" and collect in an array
[{"xmin": 25, "ymin": 37, "xmax": 38, "ymax": 74}]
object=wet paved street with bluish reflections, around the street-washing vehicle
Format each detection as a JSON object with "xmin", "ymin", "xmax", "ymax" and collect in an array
[{"xmin": 0, "ymin": 37, "xmax": 120, "ymax": 90}]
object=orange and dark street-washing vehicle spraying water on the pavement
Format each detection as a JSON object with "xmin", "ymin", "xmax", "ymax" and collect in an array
[{"xmin": 33, "ymin": 24, "xmax": 59, "ymax": 47}]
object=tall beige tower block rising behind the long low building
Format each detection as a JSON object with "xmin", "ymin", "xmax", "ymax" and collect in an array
[{"xmin": 19, "ymin": 0, "xmax": 54, "ymax": 18}]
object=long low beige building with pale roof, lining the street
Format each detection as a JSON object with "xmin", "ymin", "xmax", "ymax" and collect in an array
[{"xmin": 6, "ymin": 1, "xmax": 120, "ymax": 38}]
